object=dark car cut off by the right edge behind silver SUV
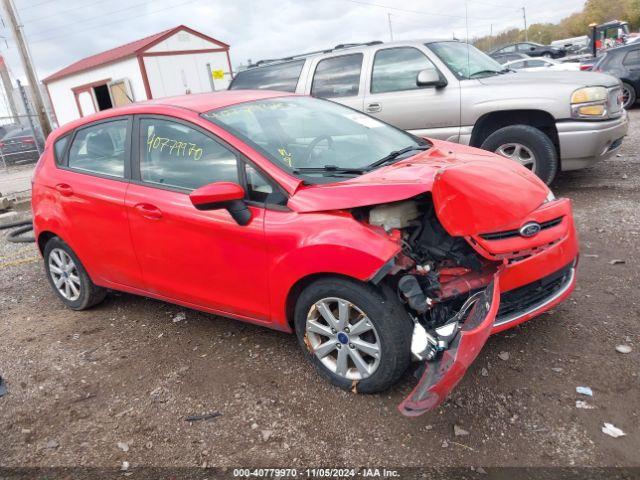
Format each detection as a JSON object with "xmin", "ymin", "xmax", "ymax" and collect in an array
[{"xmin": 593, "ymin": 43, "xmax": 640, "ymax": 109}]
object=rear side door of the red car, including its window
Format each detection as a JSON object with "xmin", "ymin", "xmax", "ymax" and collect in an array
[{"xmin": 46, "ymin": 117, "xmax": 141, "ymax": 287}]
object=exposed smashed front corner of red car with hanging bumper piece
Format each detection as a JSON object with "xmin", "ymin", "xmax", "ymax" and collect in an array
[{"xmin": 353, "ymin": 194, "xmax": 503, "ymax": 416}]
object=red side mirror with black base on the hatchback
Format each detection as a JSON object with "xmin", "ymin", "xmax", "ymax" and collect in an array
[{"xmin": 189, "ymin": 182, "xmax": 251, "ymax": 225}]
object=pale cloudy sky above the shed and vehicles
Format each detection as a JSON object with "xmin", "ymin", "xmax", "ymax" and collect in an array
[{"xmin": 0, "ymin": 0, "xmax": 584, "ymax": 114}]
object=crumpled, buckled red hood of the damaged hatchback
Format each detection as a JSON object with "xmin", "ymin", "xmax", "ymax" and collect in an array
[{"xmin": 287, "ymin": 141, "xmax": 549, "ymax": 236}]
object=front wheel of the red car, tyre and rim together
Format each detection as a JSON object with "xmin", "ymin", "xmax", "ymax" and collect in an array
[{"xmin": 294, "ymin": 278, "xmax": 413, "ymax": 393}]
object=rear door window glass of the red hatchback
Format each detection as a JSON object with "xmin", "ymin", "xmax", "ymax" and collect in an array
[{"xmin": 68, "ymin": 119, "xmax": 129, "ymax": 178}]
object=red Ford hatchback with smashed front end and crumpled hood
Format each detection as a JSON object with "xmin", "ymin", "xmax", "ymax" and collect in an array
[{"xmin": 32, "ymin": 91, "xmax": 578, "ymax": 415}]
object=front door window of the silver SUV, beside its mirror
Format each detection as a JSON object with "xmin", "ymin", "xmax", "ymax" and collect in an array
[{"xmin": 371, "ymin": 47, "xmax": 436, "ymax": 93}]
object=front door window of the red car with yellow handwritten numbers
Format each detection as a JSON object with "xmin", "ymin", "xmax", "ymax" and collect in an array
[{"xmin": 140, "ymin": 118, "xmax": 239, "ymax": 190}]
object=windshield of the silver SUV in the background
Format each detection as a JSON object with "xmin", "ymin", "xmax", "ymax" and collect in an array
[{"xmin": 426, "ymin": 42, "xmax": 504, "ymax": 79}]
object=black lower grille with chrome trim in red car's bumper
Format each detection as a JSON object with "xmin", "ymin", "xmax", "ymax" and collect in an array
[{"xmin": 496, "ymin": 263, "xmax": 574, "ymax": 325}]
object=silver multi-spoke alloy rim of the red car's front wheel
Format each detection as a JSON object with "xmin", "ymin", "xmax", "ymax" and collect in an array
[{"xmin": 306, "ymin": 297, "xmax": 381, "ymax": 380}]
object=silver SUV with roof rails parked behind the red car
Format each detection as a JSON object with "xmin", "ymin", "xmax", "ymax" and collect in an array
[{"xmin": 229, "ymin": 40, "xmax": 628, "ymax": 183}]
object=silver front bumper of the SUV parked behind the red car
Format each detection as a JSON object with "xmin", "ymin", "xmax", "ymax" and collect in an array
[{"xmin": 556, "ymin": 111, "xmax": 629, "ymax": 171}]
